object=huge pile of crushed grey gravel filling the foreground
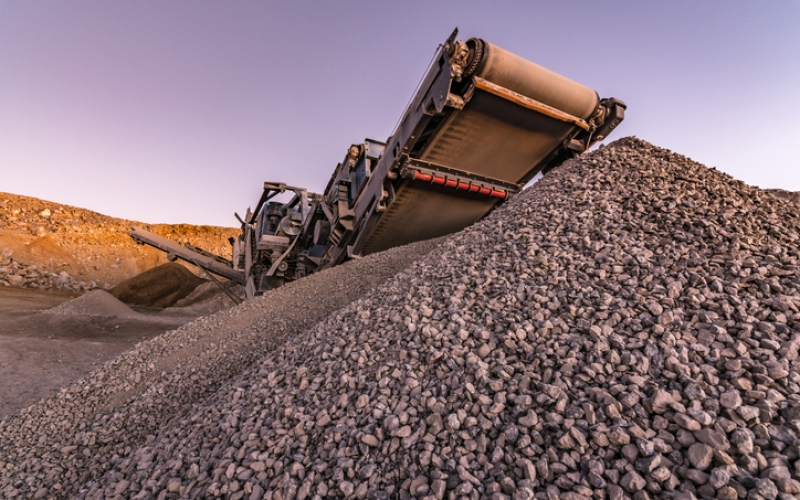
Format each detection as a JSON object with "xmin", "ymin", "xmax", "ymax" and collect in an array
[{"xmin": 0, "ymin": 138, "xmax": 800, "ymax": 500}]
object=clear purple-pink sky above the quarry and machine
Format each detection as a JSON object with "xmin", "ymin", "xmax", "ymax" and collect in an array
[{"xmin": 0, "ymin": 0, "xmax": 800, "ymax": 226}]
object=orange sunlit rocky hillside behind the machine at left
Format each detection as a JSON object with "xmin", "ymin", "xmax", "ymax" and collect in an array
[{"xmin": 0, "ymin": 193, "xmax": 239, "ymax": 291}]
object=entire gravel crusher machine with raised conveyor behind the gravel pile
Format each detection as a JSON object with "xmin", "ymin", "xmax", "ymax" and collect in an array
[{"xmin": 131, "ymin": 29, "xmax": 625, "ymax": 298}]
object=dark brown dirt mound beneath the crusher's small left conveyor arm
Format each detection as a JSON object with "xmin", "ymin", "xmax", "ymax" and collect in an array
[{"xmin": 110, "ymin": 262, "xmax": 205, "ymax": 308}]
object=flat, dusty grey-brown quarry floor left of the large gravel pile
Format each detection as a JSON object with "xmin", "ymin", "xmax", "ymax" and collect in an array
[{"xmin": 0, "ymin": 287, "xmax": 198, "ymax": 418}]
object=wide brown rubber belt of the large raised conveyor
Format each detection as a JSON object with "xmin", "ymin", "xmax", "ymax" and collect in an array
[{"xmin": 362, "ymin": 41, "xmax": 599, "ymax": 254}]
